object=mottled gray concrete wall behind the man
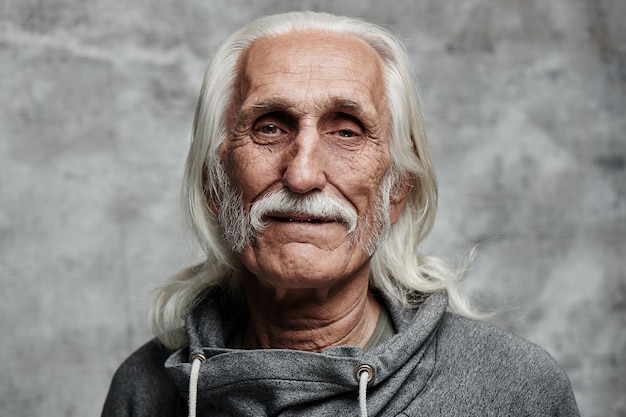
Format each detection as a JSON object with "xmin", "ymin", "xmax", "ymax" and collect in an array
[{"xmin": 0, "ymin": 0, "xmax": 626, "ymax": 417}]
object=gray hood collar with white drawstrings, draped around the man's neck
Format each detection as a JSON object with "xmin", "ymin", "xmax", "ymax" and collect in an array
[{"xmin": 165, "ymin": 292, "xmax": 447, "ymax": 417}]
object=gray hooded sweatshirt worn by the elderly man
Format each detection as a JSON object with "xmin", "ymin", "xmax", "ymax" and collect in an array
[{"xmin": 102, "ymin": 292, "xmax": 579, "ymax": 417}]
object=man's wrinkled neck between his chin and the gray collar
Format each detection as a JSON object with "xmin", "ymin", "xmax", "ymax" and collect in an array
[{"xmin": 243, "ymin": 279, "xmax": 381, "ymax": 352}]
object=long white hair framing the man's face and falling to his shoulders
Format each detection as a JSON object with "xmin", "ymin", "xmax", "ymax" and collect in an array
[{"xmin": 151, "ymin": 12, "xmax": 475, "ymax": 348}]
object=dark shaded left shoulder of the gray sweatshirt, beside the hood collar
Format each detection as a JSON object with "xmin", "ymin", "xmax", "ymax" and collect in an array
[{"xmin": 102, "ymin": 340, "xmax": 179, "ymax": 417}]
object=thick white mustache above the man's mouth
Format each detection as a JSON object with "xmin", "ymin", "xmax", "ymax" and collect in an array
[{"xmin": 250, "ymin": 188, "xmax": 359, "ymax": 233}]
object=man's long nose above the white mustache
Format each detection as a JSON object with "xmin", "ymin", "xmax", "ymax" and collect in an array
[{"xmin": 283, "ymin": 126, "xmax": 326, "ymax": 194}]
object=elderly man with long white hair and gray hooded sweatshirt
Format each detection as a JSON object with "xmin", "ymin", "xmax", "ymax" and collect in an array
[{"xmin": 103, "ymin": 13, "xmax": 578, "ymax": 416}]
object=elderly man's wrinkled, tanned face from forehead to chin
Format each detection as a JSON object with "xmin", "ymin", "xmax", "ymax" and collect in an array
[{"xmin": 220, "ymin": 32, "xmax": 402, "ymax": 289}]
